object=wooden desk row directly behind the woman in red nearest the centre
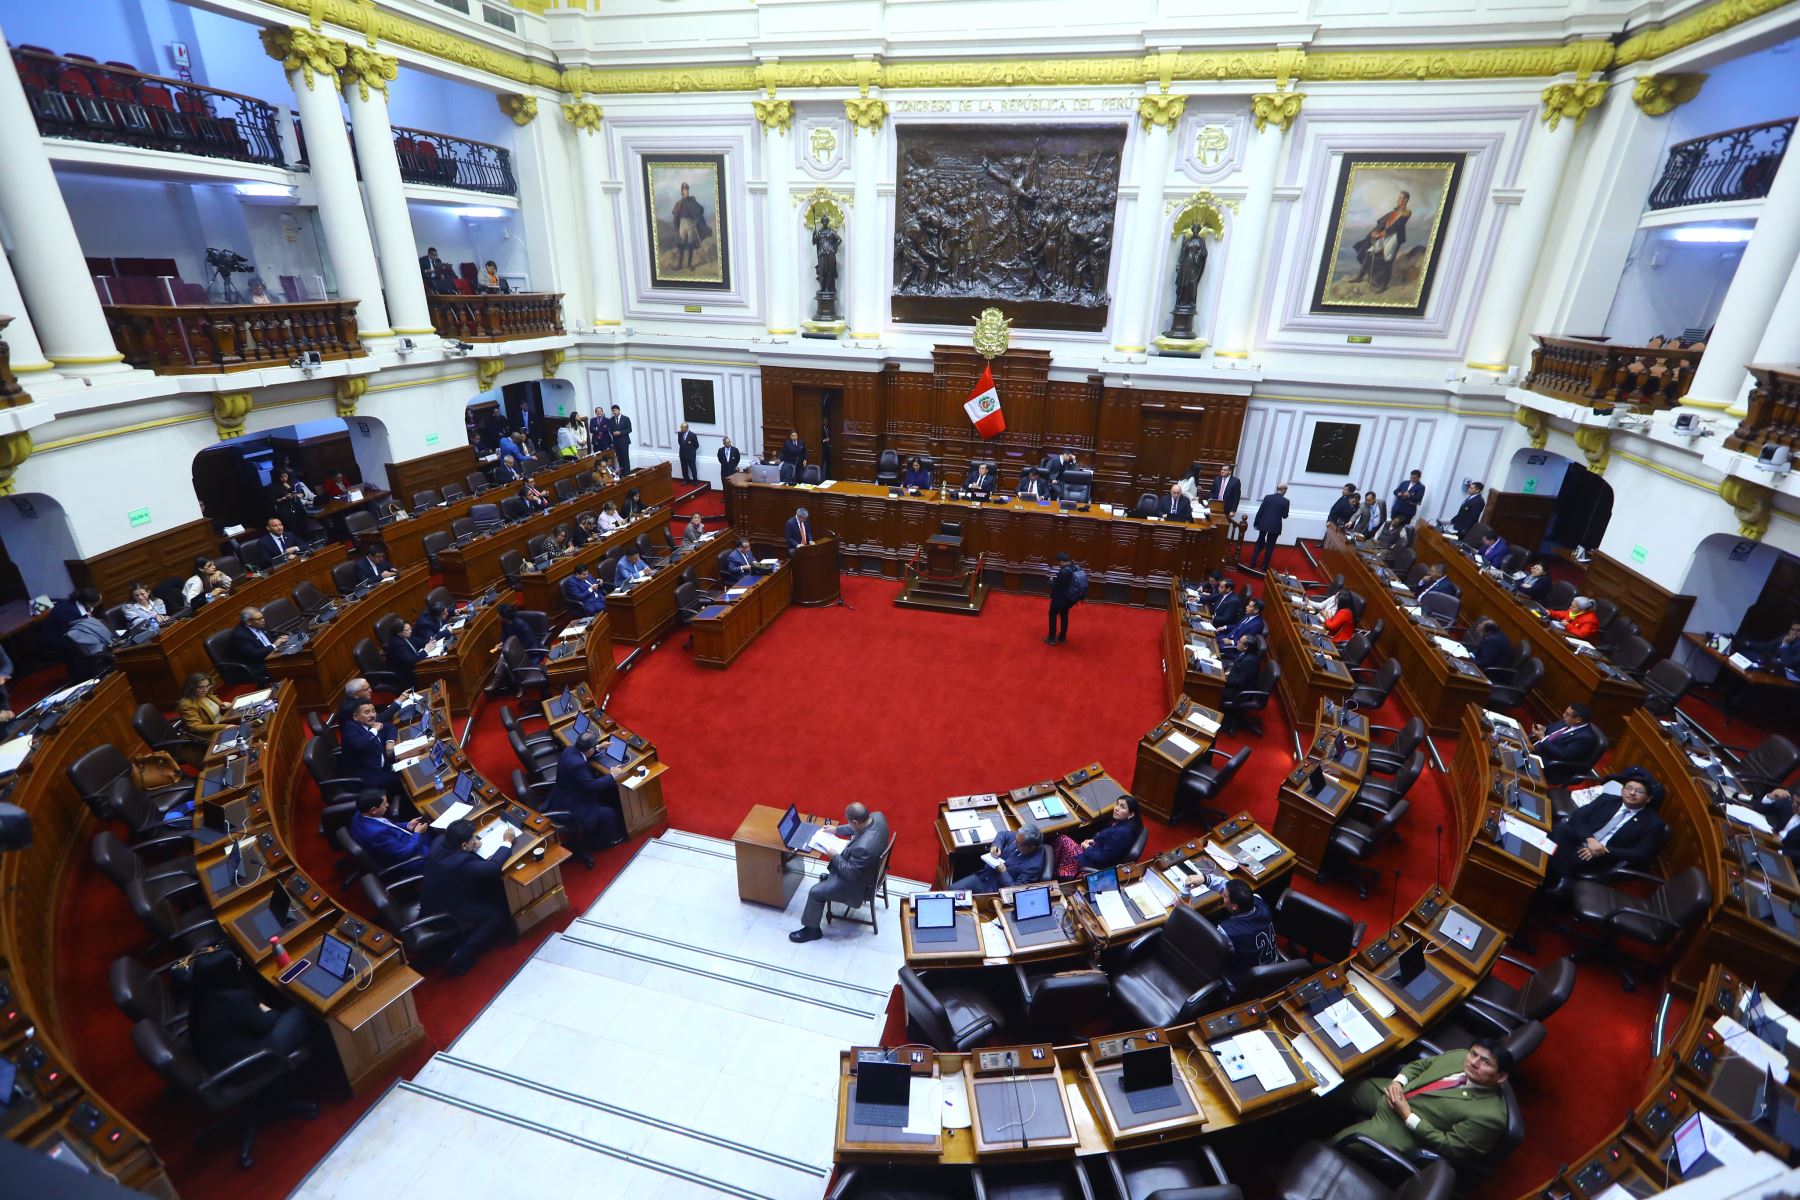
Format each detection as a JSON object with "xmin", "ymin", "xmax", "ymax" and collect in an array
[{"xmin": 1317, "ymin": 525, "xmax": 1497, "ymax": 734}]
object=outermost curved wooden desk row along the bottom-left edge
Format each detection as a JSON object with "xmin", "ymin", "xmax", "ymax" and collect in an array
[{"xmin": 0, "ymin": 673, "xmax": 175, "ymax": 1200}]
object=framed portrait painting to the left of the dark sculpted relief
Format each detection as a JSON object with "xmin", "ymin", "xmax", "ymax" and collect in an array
[{"xmin": 641, "ymin": 155, "xmax": 731, "ymax": 291}]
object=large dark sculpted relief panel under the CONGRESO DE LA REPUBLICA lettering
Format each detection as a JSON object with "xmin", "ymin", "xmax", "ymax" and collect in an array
[{"xmin": 893, "ymin": 124, "xmax": 1125, "ymax": 331}]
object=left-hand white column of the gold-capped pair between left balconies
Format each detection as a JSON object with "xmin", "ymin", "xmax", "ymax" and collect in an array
[{"xmin": 263, "ymin": 29, "xmax": 394, "ymax": 338}]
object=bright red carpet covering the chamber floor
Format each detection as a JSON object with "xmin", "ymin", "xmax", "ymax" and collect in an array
[{"xmin": 42, "ymin": 536, "xmax": 1755, "ymax": 1196}]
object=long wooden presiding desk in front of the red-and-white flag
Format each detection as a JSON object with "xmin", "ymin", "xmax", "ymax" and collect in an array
[{"xmin": 725, "ymin": 471, "xmax": 1226, "ymax": 604}]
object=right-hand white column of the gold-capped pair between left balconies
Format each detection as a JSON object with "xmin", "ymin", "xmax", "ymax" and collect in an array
[{"xmin": 338, "ymin": 47, "xmax": 437, "ymax": 336}]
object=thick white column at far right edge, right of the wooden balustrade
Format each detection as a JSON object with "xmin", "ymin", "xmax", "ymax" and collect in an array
[{"xmin": 1681, "ymin": 140, "xmax": 1800, "ymax": 416}]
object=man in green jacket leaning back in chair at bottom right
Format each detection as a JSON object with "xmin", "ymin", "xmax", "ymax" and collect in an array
[{"xmin": 1336, "ymin": 1040, "xmax": 1512, "ymax": 1162}]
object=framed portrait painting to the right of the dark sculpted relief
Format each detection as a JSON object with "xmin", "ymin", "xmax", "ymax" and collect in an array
[{"xmin": 1312, "ymin": 153, "xmax": 1463, "ymax": 317}]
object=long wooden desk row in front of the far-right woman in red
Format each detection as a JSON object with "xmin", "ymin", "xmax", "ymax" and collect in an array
[{"xmin": 1413, "ymin": 524, "xmax": 1643, "ymax": 738}]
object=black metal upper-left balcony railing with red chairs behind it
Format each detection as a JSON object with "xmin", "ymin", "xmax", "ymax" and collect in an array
[{"xmin": 13, "ymin": 49, "xmax": 284, "ymax": 167}]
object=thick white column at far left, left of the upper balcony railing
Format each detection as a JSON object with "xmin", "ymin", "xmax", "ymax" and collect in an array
[{"xmin": 0, "ymin": 25, "xmax": 130, "ymax": 374}]
